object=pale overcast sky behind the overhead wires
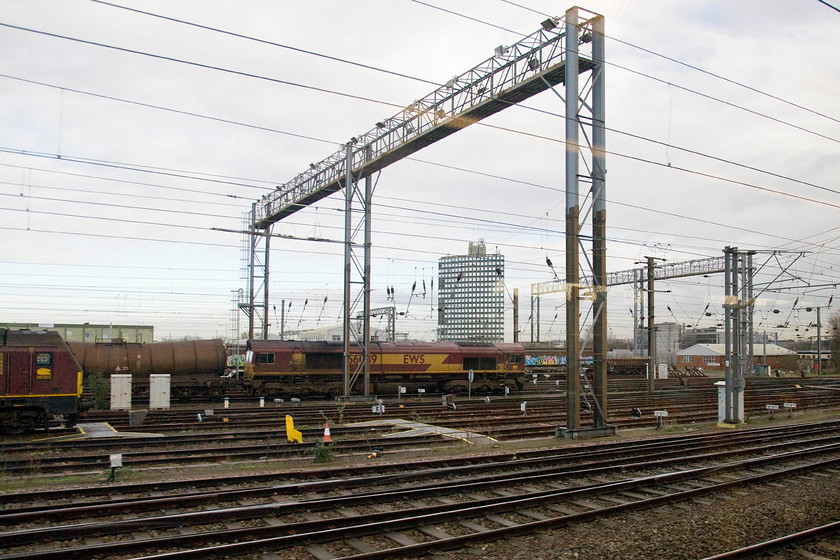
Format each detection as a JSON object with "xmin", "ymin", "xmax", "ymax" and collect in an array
[{"xmin": 0, "ymin": 0, "xmax": 840, "ymax": 346}]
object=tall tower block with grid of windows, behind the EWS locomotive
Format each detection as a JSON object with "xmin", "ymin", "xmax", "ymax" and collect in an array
[{"xmin": 438, "ymin": 240, "xmax": 505, "ymax": 342}]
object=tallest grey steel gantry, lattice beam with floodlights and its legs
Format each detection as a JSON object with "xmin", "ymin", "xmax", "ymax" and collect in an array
[{"xmin": 243, "ymin": 8, "xmax": 606, "ymax": 402}]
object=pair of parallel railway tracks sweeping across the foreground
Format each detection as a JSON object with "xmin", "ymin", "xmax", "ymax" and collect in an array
[{"xmin": 0, "ymin": 422, "xmax": 840, "ymax": 560}]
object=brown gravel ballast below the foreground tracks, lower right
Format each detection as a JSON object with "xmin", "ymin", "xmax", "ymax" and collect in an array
[{"xmin": 430, "ymin": 471, "xmax": 840, "ymax": 560}]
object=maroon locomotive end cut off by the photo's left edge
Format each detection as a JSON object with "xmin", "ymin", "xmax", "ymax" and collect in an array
[{"xmin": 0, "ymin": 329, "xmax": 82, "ymax": 433}]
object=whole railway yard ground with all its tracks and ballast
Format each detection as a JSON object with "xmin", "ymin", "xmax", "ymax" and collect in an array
[{"xmin": 0, "ymin": 378, "xmax": 840, "ymax": 560}]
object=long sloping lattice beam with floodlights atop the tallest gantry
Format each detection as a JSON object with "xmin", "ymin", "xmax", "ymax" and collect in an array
[{"xmin": 252, "ymin": 7, "xmax": 596, "ymax": 229}]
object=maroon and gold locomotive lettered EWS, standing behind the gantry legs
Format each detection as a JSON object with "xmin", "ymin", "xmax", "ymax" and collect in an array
[{"xmin": 245, "ymin": 340, "xmax": 525, "ymax": 397}]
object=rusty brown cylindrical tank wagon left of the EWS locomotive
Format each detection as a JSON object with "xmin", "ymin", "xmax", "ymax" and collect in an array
[{"xmin": 69, "ymin": 339, "xmax": 227, "ymax": 377}]
